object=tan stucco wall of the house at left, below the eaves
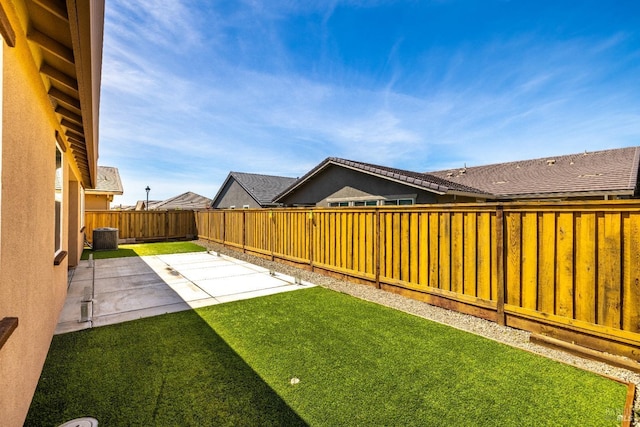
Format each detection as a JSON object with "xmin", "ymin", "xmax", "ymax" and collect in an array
[{"xmin": 0, "ymin": 0, "xmax": 104, "ymax": 427}]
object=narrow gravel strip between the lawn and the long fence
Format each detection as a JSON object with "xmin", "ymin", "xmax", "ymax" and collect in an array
[{"xmin": 198, "ymin": 239, "xmax": 640, "ymax": 427}]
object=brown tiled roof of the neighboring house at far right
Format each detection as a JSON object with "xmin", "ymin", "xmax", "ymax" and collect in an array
[{"xmin": 429, "ymin": 147, "xmax": 640, "ymax": 200}]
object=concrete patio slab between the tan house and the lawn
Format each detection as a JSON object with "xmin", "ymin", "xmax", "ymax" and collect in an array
[{"xmin": 56, "ymin": 252, "xmax": 314, "ymax": 334}]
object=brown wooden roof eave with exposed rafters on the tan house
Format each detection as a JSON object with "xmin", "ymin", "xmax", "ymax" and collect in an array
[{"xmin": 24, "ymin": 0, "xmax": 104, "ymax": 188}]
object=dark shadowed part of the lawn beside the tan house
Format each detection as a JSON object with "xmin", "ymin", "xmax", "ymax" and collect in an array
[{"xmin": 25, "ymin": 311, "xmax": 306, "ymax": 426}]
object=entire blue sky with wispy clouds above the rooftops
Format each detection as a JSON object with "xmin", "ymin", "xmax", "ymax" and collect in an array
[{"xmin": 98, "ymin": 0, "xmax": 640, "ymax": 204}]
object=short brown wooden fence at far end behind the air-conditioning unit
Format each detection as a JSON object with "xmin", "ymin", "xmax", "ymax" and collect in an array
[{"xmin": 85, "ymin": 210, "xmax": 198, "ymax": 242}]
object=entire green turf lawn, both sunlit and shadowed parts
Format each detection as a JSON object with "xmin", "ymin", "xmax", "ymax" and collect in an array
[{"xmin": 26, "ymin": 288, "xmax": 626, "ymax": 426}]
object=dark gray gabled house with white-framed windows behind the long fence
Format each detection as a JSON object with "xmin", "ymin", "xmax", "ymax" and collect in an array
[{"xmin": 274, "ymin": 157, "xmax": 490, "ymax": 207}]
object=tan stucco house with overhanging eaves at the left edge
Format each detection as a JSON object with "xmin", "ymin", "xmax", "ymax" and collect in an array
[{"xmin": 0, "ymin": 0, "xmax": 104, "ymax": 427}]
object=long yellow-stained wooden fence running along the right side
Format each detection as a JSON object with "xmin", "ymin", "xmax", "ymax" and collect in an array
[{"xmin": 196, "ymin": 201, "xmax": 640, "ymax": 360}]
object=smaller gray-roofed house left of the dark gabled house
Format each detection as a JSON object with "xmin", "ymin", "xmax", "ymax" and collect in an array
[{"xmin": 211, "ymin": 172, "xmax": 296, "ymax": 209}]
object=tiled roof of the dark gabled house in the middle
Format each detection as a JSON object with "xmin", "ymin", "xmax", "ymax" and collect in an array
[{"xmin": 274, "ymin": 157, "xmax": 486, "ymax": 200}]
